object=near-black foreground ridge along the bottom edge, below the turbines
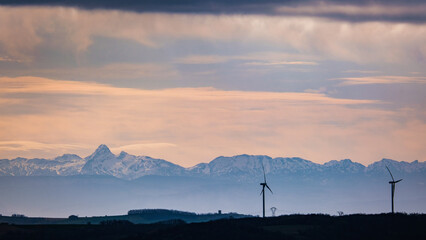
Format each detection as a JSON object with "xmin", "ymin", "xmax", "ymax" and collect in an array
[{"xmin": 0, "ymin": 214, "xmax": 426, "ymax": 240}]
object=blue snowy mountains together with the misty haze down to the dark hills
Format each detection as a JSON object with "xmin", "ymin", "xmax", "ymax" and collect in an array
[{"xmin": 0, "ymin": 145, "xmax": 426, "ymax": 217}]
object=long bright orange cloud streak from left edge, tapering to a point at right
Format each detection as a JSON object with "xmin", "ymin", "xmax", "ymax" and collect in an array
[{"xmin": 0, "ymin": 76, "xmax": 378, "ymax": 105}]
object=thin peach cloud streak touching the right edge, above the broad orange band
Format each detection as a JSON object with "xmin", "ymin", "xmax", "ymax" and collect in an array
[{"xmin": 333, "ymin": 76, "xmax": 426, "ymax": 85}]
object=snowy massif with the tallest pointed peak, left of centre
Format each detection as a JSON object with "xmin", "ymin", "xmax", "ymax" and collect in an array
[{"xmin": 81, "ymin": 145, "xmax": 185, "ymax": 180}]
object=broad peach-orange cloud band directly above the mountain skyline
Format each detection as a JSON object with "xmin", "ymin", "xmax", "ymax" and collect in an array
[{"xmin": 0, "ymin": 76, "xmax": 426, "ymax": 166}]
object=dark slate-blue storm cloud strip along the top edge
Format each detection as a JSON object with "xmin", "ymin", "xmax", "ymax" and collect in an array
[{"xmin": 0, "ymin": 0, "xmax": 426, "ymax": 23}]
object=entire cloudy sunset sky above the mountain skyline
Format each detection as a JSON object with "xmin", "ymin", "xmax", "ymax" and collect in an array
[{"xmin": 0, "ymin": 0, "xmax": 426, "ymax": 167}]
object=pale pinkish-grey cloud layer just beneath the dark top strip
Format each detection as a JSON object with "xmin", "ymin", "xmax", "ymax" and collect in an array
[{"xmin": 0, "ymin": 7, "xmax": 426, "ymax": 66}]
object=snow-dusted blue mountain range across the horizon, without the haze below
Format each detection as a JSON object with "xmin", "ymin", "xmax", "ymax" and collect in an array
[{"xmin": 0, "ymin": 144, "xmax": 426, "ymax": 180}]
